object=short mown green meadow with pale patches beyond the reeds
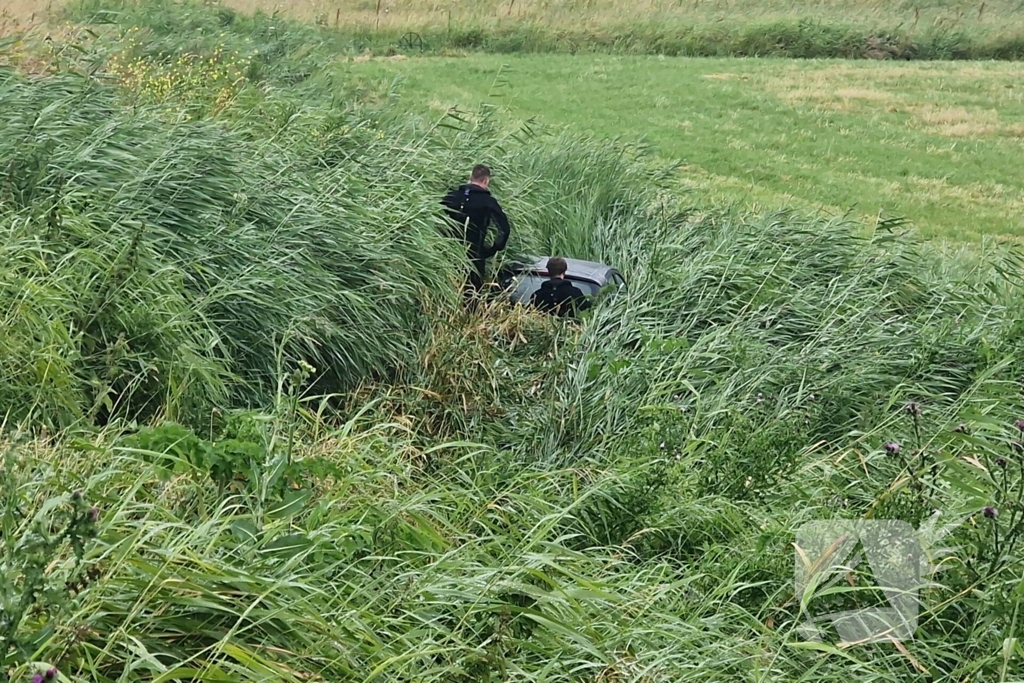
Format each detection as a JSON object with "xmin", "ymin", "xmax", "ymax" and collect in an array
[{"xmin": 344, "ymin": 55, "xmax": 1024, "ymax": 241}]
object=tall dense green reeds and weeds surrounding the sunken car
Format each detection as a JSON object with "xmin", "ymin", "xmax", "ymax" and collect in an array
[{"xmin": 0, "ymin": 5, "xmax": 1024, "ymax": 682}]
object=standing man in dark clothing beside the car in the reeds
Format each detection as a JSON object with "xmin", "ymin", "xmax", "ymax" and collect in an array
[{"xmin": 441, "ymin": 164, "xmax": 510, "ymax": 296}]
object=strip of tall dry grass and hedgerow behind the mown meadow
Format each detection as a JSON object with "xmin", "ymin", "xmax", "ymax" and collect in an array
[{"xmin": 56, "ymin": 0, "xmax": 1024, "ymax": 60}]
